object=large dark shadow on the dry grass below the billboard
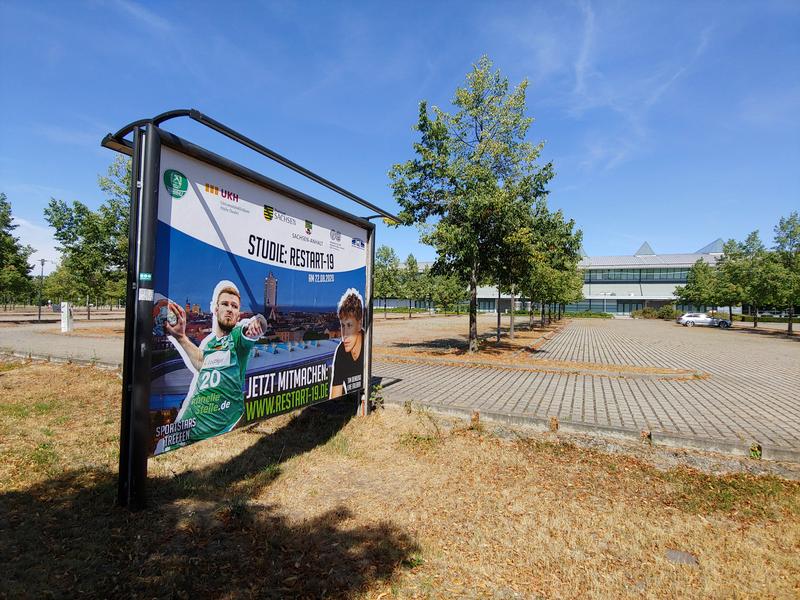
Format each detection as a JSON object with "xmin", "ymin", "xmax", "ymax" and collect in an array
[{"xmin": 0, "ymin": 402, "xmax": 418, "ymax": 598}]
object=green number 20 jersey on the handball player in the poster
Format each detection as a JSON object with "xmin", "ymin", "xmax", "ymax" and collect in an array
[{"xmin": 181, "ymin": 325, "xmax": 255, "ymax": 442}]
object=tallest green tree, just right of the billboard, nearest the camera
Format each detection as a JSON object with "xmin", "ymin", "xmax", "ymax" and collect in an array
[{"xmin": 390, "ymin": 56, "xmax": 553, "ymax": 352}]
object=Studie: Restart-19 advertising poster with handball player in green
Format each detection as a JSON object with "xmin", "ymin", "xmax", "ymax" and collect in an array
[{"xmin": 148, "ymin": 146, "xmax": 368, "ymax": 455}]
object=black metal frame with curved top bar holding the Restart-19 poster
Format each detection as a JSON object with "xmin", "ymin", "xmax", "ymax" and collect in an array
[{"xmin": 101, "ymin": 109, "xmax": 392, "ymax": 510}]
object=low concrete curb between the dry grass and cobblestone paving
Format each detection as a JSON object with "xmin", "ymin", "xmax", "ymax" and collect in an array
[{"xmin": 386, "ymin": 399, "xmax": 800, "ymax": 463}]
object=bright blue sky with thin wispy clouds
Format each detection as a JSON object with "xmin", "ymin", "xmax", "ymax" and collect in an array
[{"xmin": 0, "ymin": 0, "xmax": 800, "ymax": 272}]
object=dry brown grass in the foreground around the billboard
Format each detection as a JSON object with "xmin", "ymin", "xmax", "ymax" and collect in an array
[{"xmin": 0, "ymin": 363, "xmax": 800, "ymax": 598}]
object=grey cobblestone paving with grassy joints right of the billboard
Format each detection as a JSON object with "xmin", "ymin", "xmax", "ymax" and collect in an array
[{"xmin": 373, "ymin": 319, "xmax": 800, "ymax": 451}]
